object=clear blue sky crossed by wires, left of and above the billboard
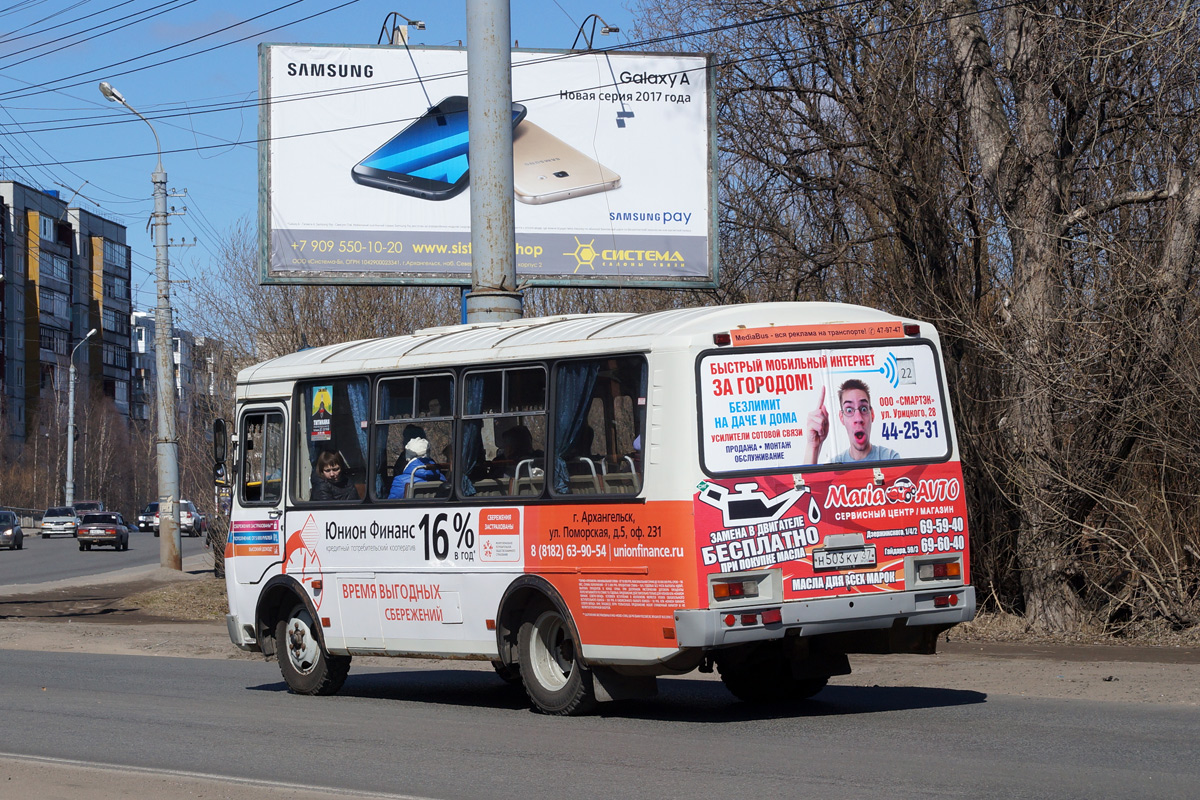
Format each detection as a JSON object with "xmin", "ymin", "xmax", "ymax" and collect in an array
[{"xmin": 0, "ymin": 0, "xmax": 632, "ymax": 316}]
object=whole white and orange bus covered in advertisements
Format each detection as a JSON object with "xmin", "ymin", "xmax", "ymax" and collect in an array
[{"xmin": 215, "ymin": 303, "xmax": 976, "ymax": 714}]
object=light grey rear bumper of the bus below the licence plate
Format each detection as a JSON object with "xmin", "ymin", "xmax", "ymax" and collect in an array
[{"xmin": 674, "ymin": 587, "xmax": 976, "ymax": 649}]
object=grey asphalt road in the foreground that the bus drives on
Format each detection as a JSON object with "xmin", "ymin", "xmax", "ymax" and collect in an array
[{"xmin": 0, "ymin": 650, "xmax": 1200, "ymax": 800}]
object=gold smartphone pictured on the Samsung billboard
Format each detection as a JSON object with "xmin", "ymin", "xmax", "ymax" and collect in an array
[{"xmin": 512, "ymin": 120, "xmax": 620, "ymax": 205}]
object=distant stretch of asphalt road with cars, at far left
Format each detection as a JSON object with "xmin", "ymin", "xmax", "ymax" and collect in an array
[{"xmin": 0, "ymin": 531, "xmax": 211, "ymax": 587}]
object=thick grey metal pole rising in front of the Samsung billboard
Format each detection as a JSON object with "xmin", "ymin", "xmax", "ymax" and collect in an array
[{"xmin": 467, "ymin": 0, "xmax": 522, "ymax": 323}]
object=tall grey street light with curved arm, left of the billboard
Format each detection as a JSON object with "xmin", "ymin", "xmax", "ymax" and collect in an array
[{"xmin": 100, "ymin": 82, "xmax": 184, "ymax": 570}]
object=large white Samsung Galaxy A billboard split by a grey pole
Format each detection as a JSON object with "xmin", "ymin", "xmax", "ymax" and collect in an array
[{"xmin": 259, "ymin": 44, "xmax": 716, "ymax": 287}]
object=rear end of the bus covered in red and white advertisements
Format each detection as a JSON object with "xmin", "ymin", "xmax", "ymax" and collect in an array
[{"xmin": 674, "ymin": 306, "xmax": 976, "ymax": 699}]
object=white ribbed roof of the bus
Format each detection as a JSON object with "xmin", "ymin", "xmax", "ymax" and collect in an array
[{"xmin": 238, "ymin": 302, "xmax": 898, "ymax": 385}]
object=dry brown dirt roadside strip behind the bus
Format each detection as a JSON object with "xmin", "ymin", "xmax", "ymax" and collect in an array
[{"xmin": 0, "ymin": 564, "xmax": 1200, "ymax": 705}]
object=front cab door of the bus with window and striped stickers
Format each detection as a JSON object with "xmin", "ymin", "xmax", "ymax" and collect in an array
[{"xmin": 234, "ymin": 403, "xmax": 287, "ymax": 583}]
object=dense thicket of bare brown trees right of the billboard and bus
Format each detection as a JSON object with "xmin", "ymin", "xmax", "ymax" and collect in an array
[{"xmin": 638, "ymin": 0, "xmax": 1200, "ymax": 630}]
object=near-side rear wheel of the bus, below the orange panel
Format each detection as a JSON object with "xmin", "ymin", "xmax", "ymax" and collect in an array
[{"xmin": 517, "ymin": 603, "xmax": 596, "ymax": 716}]
